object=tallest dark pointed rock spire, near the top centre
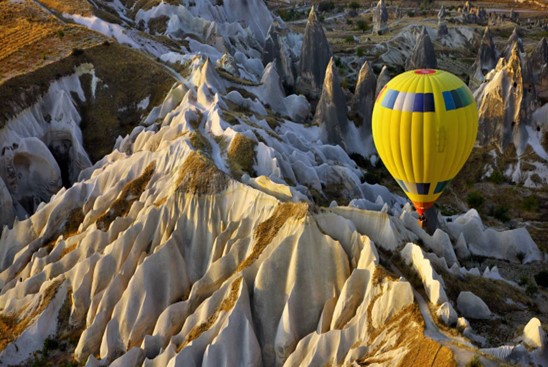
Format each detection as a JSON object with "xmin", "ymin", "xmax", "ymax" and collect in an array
[{"xmin": 296, "ymin": 6, "xmax": 331, "ymax": 99}]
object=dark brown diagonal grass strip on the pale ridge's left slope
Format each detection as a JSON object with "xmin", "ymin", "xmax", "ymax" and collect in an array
[{"xmin": 96, "ymin": 162, "xmax": 155, "ymax": 232}]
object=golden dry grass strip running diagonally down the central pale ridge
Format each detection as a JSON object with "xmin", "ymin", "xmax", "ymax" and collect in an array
[{"xmin": 236, "ymin": 203, "xmax": 308, "ymax": 272}]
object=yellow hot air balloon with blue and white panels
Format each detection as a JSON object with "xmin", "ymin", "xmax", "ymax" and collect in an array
[{"xmin": 372, "ymin": 69, "xmax": 478, "ymax": 226}]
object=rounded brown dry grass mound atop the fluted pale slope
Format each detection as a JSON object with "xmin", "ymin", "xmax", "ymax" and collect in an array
[{"xmin": 176, "ymin": 152, "xmax": 228, "ymax": 195}]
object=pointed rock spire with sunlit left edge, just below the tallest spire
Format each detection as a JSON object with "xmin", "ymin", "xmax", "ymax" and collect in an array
[{"xmin": 314, "ymin": 58, "xmax": 348, "ymax": 148}]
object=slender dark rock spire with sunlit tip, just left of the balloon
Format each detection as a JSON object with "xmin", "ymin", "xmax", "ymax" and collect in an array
[{"xmin": 352, "ymin": 61, "xmax": 377, "ymax": 135}]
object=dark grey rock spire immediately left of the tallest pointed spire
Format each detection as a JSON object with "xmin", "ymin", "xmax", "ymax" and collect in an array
[{"xmin": 262, "ymin": 22, "xmax": 295, "ymax": 89}]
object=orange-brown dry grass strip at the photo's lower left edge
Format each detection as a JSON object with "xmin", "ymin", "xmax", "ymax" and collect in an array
[{"xmin": 0, "ymin": 280, "xmax": 62, "ymax": 351}]
